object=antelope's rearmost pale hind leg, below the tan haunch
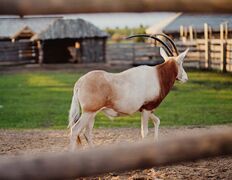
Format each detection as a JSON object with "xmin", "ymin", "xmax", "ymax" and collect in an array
[{"xmin": 70, "ymin": 112, "xmax": 95, "ymax": 151}]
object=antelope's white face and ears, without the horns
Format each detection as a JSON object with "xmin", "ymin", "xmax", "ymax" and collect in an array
[{"xmin": 160, "ymin": 48, "xmax": 189, "ymax": 83}]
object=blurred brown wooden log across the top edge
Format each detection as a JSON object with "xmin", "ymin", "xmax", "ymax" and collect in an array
[{"xmin": 0, "ymin": 0, "xmax": 232, "ymax": 15}]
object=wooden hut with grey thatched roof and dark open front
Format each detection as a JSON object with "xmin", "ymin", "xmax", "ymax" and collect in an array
[{"xmin": 31, "ymin": 19, "xmax": 107, "ymax": 63}]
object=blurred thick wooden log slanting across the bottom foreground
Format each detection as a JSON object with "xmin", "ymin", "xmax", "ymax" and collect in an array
[{"xmin": 0, "ymin": 129, "xmax": 232, "ymax": 180}]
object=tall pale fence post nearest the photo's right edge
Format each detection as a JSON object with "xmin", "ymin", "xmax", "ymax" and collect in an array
[{"xmin": 220, "ymin": 24, "xmax": 227, "ymax": 72}]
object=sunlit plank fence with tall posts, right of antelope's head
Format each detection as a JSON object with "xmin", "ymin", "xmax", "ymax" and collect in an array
[{"xmin": 173, "ymin": 24, "xmax": 232, "ymax": 72}]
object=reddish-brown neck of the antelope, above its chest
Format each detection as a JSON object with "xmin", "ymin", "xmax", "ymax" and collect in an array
[{"xmin": 157, "ymin": 59, "xmax": 178, "ymax": 99}]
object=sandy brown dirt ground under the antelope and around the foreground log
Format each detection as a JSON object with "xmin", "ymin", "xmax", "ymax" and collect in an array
[{"xmin": 0, "ymin": 125, "xmax": 232, "ymax": 180}]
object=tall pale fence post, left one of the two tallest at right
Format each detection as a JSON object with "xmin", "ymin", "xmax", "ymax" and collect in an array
[{"xmin": 204, "ymin": 23, "xmax": 211, "ymax": 69}]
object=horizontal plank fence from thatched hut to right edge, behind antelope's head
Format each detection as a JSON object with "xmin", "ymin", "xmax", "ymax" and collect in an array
[{"xmin": 106, "ymin": 37, "xmax": 232, "ymax": 72}]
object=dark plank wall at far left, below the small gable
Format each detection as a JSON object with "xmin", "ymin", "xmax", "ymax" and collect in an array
[{"xmin": 0, "ymin": 41, "xmax": 38, "ymax": 65}]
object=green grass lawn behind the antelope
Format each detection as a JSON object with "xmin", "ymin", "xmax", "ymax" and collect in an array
[{"xmin": 0, "ymin": 71, "xmax": 232, "ymax": 128}]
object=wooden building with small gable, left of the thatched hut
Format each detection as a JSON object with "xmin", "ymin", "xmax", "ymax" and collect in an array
[{"xmin": 0, "ymin": 16, "xmax": 58, "ymax": 65}]
